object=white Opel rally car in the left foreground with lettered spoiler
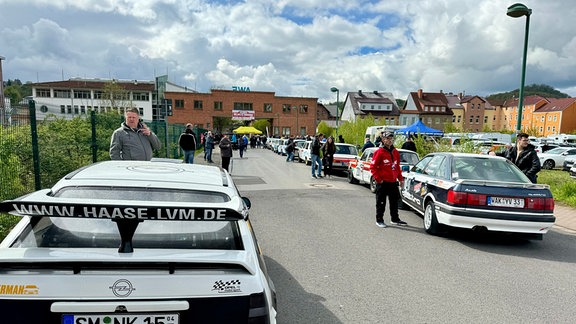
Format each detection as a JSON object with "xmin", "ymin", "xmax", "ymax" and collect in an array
[{"xmin": 0, "ymin": 161, "xmax": 276, "ymax": 324}]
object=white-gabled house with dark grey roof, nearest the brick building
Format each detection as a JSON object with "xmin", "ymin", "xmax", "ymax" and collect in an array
[{"xmin": 341, "ymin": 90, "xmax": 400, "ymax": 125}]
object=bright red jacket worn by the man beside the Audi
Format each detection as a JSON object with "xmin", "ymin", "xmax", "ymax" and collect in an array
[{"xmin": 370, "ymin": 146, "xmax": 404, "ymax": 183}]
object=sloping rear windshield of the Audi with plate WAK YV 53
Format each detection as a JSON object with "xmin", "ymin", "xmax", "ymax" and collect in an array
[{"xmin": 452, "ymin": 157, "xmax": 530, "ymax": 183}]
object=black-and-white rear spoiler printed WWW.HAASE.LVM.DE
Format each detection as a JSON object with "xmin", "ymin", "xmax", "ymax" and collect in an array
[{"xmin": 0, "ymin": 189, "xmax": 249, "ymax": 253}]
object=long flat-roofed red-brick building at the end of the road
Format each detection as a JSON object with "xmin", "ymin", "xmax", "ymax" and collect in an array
[{"xmin": 164, "ymin": 89, "xmax": 320, "ymax": 136}]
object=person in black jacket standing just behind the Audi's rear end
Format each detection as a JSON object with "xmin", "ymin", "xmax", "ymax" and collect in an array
[{"xmin": 489, "ymin": 133, "xmax": 542, "ymax": 183}]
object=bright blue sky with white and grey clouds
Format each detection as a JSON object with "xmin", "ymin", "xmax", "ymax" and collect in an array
[{"xmin": 0, "ymin": 0, "xmax": 576, "ymax": 102}]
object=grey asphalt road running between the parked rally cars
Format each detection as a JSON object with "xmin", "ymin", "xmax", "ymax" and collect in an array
[{"xmin": 227, "ymin": 149, "xmax": 576, "ymax": 323}]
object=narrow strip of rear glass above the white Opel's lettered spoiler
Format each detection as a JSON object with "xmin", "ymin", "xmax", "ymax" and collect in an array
[{"xmin": 54, "ymin": 186, "xmax": 230, "ymax": 203}]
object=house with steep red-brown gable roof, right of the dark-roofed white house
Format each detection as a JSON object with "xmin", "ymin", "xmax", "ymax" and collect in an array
[{"xmin": 400, "ymin": 89, "xmax": 452, "ymax": 130}]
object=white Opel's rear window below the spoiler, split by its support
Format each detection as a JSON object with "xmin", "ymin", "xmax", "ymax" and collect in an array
[{"xmin": 12, "ymin": 217, "xmax": 243, "ymax": 250}]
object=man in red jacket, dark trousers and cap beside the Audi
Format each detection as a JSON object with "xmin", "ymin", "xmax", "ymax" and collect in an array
[{"xmin": 370, "ymin": 132, "xmax": 406, "ymax": 227}]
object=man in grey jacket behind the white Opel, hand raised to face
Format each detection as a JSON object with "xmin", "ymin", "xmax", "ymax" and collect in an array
[{"xmin": 109, "ymin": 107, "xmax": 162, "ymax": 161}]
